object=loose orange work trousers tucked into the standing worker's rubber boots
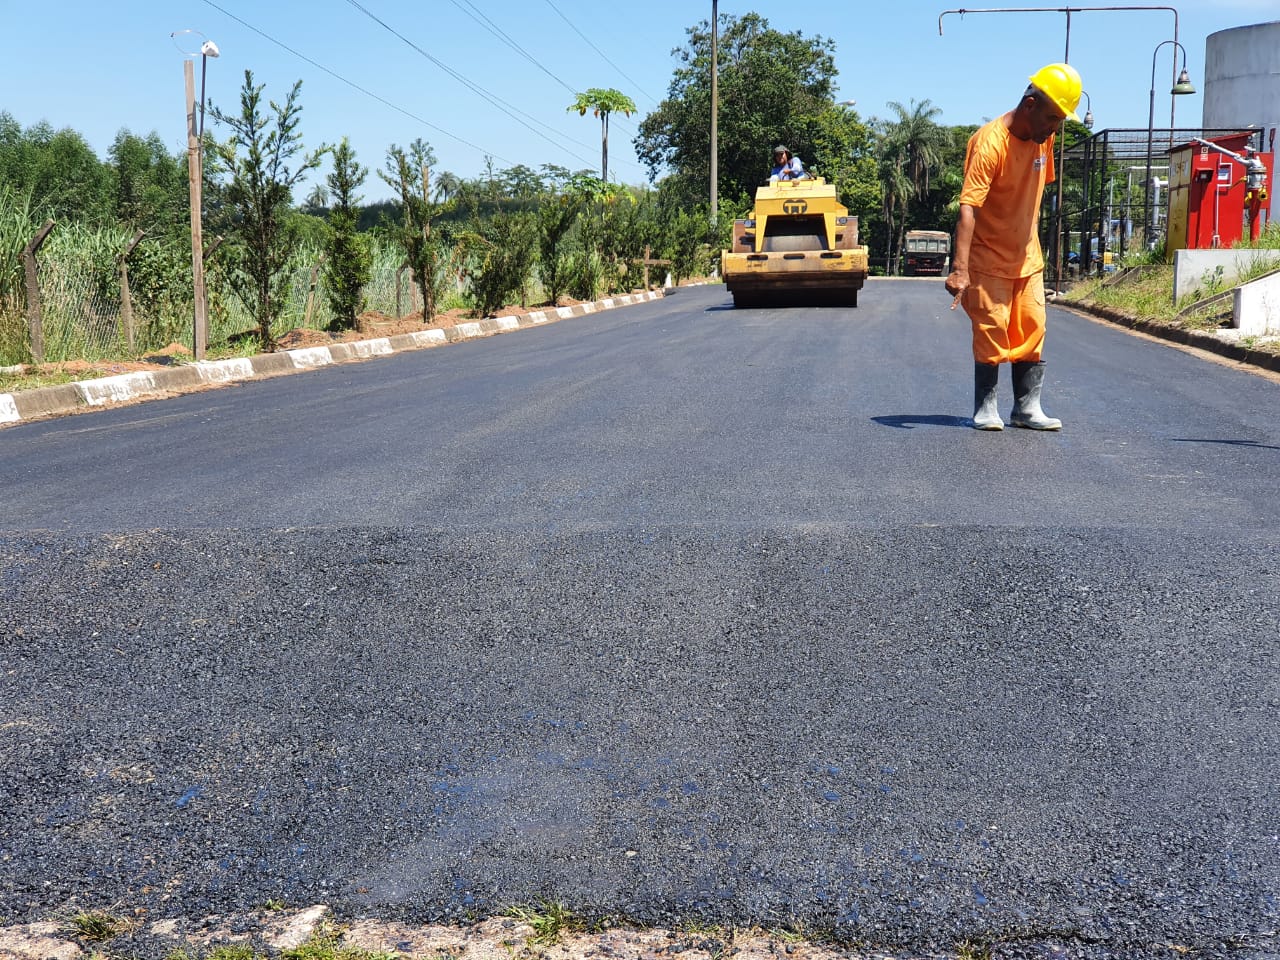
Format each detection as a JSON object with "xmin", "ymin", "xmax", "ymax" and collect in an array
[{"xmin": 960, "ymin": 271, "xmax": 1044, "ymax": 364}]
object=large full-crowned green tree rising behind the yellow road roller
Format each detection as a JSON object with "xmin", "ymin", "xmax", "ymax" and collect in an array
[{"xmin": 635, "ymin": 13, "xmax": 837, "ymax": 207}]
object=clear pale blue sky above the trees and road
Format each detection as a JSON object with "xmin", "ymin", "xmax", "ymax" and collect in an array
[{"xmin": 0, "ymin": 0, "xmax": 1280, "ymax": 200}]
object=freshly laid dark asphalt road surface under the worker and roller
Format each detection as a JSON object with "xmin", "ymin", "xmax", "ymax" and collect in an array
[{"xmin": 0, "ymin": 280, "xmax": 1280, "ymax": 959}]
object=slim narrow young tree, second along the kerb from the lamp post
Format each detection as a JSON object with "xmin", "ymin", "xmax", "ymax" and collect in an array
[{"xmin": 324, "ymin": 137, "xmax": 372, "ymax": 330}]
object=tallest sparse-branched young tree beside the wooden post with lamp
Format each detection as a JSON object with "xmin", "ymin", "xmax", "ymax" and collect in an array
[{"xmin": 210, "ymin": 70, "xmax": 325, "ymax": 351}]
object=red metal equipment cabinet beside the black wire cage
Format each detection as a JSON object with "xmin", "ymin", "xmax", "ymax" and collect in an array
[{"xmin": 1165, "ymin": 131, "xmax": 1274, "ymax": 262}]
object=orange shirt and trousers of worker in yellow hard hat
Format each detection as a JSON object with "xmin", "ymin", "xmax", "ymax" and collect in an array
[{"xmin": 960, "ymin": 118, "xmax": 1055, "ymax": 364}]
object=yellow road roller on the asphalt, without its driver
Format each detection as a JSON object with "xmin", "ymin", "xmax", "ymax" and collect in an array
[{"xmin": 721, "ymin": 177, "xmax": 869, "ymax": 307}]
